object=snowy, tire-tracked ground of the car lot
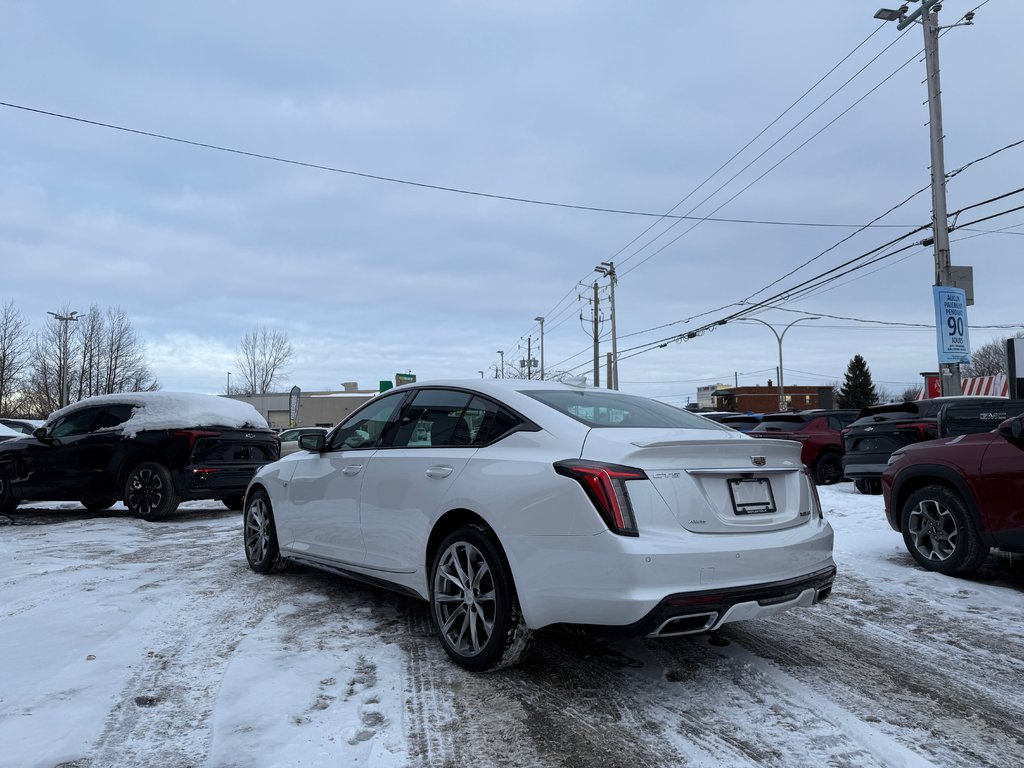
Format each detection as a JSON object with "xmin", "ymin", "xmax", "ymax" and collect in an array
[{"xmin": 0, "ymin": 483, "xmax": 1024, "ymax": 768}]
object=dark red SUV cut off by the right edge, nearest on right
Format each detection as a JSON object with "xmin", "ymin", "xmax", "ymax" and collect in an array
[{"xmin": 882, "ymin": 415, "xmax": 1024, "ymax": 574}]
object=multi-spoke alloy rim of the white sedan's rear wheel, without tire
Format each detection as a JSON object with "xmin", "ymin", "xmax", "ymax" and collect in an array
[{"xmin": 433, "ymin": 541, "xmax": 498, "ymax": 656}]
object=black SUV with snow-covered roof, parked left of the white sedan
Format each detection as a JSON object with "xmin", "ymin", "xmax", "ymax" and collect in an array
[{"xmin": 0, "ymin": 392, "xmax": 281, "ymax": 520}]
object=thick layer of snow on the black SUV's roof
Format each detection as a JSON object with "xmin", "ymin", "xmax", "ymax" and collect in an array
[{"xmin": 46, "ymin": 392, "xmax": 270, "ymax": 437}]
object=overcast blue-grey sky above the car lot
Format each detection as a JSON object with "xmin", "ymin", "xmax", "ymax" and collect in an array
[{"xmin": 0, "ymin": 0, "xmax": 1024, "ymax": 404}]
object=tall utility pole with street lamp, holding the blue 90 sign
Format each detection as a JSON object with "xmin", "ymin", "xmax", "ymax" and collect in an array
[{"xmin": 874, "ymin": 0, "xmax": 974, "ymax": 396}]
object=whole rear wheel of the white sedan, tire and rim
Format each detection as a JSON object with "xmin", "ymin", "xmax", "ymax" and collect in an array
[{"xmin": 430, "ymin": 525, "xmax": 531, "ymax": 672}]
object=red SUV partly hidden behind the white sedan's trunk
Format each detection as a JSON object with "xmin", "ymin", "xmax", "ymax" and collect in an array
[{"xmin": 746, "ymin": 409, "xmax": 858, "ymax": 485}]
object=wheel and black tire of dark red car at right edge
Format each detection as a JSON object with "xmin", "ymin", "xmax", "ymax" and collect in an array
[{"xmin": 900, "ymin": 485, "xmax": 988, "ymax": 575}]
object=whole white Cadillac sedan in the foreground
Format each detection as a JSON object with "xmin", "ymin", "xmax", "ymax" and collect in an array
[{"xmin": 244, "ymin": 379, "xmax": 836, "ymax": 670}]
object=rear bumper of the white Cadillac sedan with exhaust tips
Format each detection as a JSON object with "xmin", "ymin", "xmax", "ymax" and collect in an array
[{"xmin": 503, "ymin": 519, "xmax": 836, "ymax": 637}]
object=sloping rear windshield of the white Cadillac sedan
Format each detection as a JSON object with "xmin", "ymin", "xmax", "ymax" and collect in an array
[{"xmin": 523, "ymin": 389, "xmax": 732, "ymax": 431}]
